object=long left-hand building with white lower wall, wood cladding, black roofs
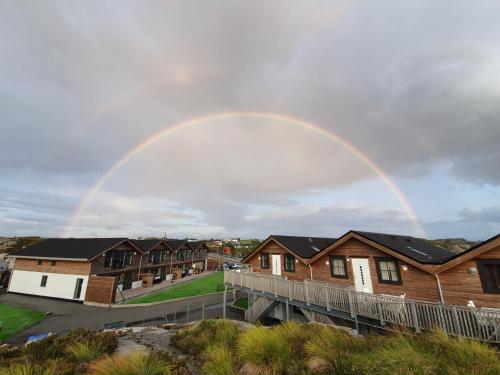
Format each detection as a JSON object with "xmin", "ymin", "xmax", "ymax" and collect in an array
[{"xmin": 8, "ymin": 238, "xmax": 205, "ymax": 304}]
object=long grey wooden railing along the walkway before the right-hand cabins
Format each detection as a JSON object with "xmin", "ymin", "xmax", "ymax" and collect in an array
[{"xmin": 224, "ymin": 270, "xmax": 500, "ymax": 343}]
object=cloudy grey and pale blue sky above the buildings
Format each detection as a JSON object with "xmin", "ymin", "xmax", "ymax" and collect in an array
[{"xmin": 0, "ymin": 0, "xmax": 500, "ymax": 240}]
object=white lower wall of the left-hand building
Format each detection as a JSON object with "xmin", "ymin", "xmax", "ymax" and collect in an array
[{"xmin": 9, "ymin": 270, "xmax": 88, "ymax": 301}]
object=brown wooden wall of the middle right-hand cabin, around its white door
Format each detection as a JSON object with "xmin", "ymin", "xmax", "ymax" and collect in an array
[{"xmin": 311, "ymin": 238, "xmax": 439, "ymax": 302}]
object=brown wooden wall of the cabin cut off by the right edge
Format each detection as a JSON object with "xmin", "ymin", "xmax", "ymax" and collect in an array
[{"xmin": 439, "ymin": 246, "xmax": 500, "ymax": 308}]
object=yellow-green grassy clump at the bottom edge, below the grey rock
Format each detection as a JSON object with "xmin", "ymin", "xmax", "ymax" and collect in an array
[{"xmin": 89, "ymin": 353, "xmax": 172, "ymax": 375}]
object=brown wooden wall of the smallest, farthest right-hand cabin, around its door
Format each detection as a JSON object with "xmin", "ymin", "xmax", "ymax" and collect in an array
[{"xmin": 246, "ymin": 240, "xmax": 310, "ymax": 281}]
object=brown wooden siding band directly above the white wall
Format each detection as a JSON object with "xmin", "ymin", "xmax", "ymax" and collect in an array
[{"xmin": 14, "ymin": 258, "xmax": 90, "ymax": 275}]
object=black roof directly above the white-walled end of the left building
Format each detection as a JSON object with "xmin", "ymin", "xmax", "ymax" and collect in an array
[{"xmin": 11, "ymin": 238, "xmax": 131, "ymax": 260}]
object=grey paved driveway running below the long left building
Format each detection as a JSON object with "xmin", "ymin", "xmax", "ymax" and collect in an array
[{"xmin": 0, "ymin": 293, "xmax": 241, "ymax": 343}]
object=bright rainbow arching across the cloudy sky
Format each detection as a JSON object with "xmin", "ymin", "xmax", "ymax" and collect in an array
[{"xmin": 63, "ymin": 112, "xmax": 425, "ymax": 237}]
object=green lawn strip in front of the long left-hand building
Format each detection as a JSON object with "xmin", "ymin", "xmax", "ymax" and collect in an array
[{"xmin": 126, "ymin": 272, "xmax": 224, "ymax": 304}]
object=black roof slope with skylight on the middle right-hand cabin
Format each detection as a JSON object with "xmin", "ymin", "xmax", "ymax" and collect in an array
[{"xmin": 352, "ymin": 230, "xmax": 456, "ymax": 264}]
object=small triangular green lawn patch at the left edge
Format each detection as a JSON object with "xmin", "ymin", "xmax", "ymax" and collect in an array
[{"xmin": 0, "ymin": 304, "xmax": 45, "ymax": 341}]
